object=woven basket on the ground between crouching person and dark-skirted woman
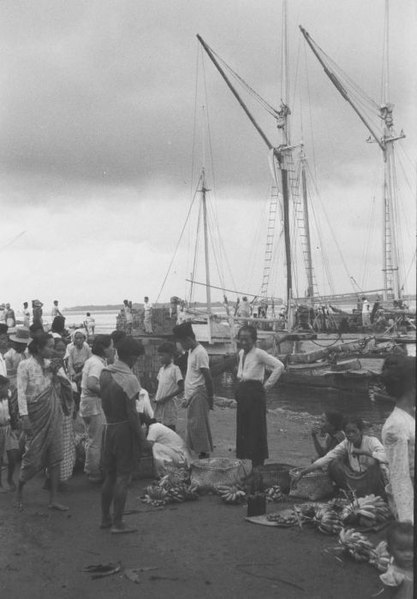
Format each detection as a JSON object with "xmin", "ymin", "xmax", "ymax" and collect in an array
[{"xmin": 191, "ymin": 458, "xmax": 251, "ymax": 493}]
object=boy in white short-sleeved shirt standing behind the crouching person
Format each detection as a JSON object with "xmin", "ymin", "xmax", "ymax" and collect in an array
[{"xmin": 155, "ymin": 343, "xmax": 184, "ymax": 431}]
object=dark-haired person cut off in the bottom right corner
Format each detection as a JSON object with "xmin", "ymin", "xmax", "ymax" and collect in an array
[{"xmin": 380, "ymin": 522, "xmax": 414, "ymax": 599}]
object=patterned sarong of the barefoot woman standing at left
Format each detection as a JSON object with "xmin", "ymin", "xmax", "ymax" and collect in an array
[{"xmin": 19, "ymin": 383, "xmax": 63, "ymax": 482}]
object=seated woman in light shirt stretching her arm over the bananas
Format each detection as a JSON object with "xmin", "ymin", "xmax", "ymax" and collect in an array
[{"xmin": 299, "ymin": 418, "xmax": 387, "ymax": 497}]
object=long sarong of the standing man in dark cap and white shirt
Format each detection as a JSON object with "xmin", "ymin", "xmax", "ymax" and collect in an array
[{"xmin": 187, "ymin": 387, "xmax": 213, "ymax": 453}]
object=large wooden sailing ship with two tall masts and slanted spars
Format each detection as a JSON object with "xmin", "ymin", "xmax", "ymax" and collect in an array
[{"xmin": 197, "ymin": 0, "xmax": 415, "ymax": 390}]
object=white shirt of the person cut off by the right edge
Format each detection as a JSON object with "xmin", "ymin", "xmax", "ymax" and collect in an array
[{"xmin": 382, "ymin": 407, "xmax": 416, "ymax": 522}]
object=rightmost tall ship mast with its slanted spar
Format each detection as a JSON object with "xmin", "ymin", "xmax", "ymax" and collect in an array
[{"xmin": 300, "ymin": 0, "xmax": 405, "ymax": 300}]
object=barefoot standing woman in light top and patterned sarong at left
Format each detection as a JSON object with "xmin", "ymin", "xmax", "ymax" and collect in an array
[{"xmin": 17, "ymin": 334, "xmax": 69, "ymax": 511}]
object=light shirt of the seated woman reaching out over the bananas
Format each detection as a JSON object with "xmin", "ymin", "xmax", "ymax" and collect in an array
[{"xmin": 314, "ymin": 435, "xmax": 387, "ymax": 472}]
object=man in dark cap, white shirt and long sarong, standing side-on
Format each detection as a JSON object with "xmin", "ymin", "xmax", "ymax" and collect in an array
[{"xmin": 173, "ymin": 322, "xmax": 213, "ymax": 459}]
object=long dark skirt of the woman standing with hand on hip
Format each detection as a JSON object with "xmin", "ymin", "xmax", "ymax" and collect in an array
[{"xmin": 235, "ymin": 381, "xmax": 268, "ymax": 465}]
